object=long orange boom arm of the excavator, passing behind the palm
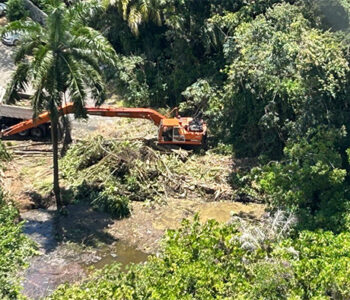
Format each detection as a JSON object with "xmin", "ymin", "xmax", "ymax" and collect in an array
[{"xmin": 0, "ymin": 103, "xmax": 165, "ymax": 137}]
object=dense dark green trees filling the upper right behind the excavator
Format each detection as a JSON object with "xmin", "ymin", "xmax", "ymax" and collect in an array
[{"xmin": 87, "ymin": 0, "xmax": 350, "ymax": 231}]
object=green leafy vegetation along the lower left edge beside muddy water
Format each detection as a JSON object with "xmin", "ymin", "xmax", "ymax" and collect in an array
[{"xmin": 0, "ymin": 141, "xmax": 34, "ymax": 299}]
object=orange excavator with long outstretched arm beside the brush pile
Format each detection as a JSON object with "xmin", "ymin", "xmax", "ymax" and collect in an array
[{"xmin": 0, "ymin": 103, "xmax": 207, "ymax": 146}]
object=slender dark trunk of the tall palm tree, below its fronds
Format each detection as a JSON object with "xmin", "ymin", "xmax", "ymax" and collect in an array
[{"xmin": 51, "ymin": 116, "xmax": 62, "ymax": 210}]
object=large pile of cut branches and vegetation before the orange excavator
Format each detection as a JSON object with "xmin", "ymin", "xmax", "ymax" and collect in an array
[{"xmin": 61, "ymin": 136, "xmax": 232, "ymax": 217}]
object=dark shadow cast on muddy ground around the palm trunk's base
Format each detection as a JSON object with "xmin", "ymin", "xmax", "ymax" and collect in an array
[{"xmin": 22, "ymin": 189, "xmax": 117, "ymax": 253}]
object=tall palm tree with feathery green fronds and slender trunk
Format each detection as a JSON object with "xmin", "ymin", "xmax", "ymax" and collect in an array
[{"xmin": 5, "ymin": 0, "xmax": 115, "ymax": 210}]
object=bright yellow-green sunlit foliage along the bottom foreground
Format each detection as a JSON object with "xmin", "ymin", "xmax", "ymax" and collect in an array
[{"xmin": 50, "ymin": 219, "xmax": 350, "ymax": 299}]
